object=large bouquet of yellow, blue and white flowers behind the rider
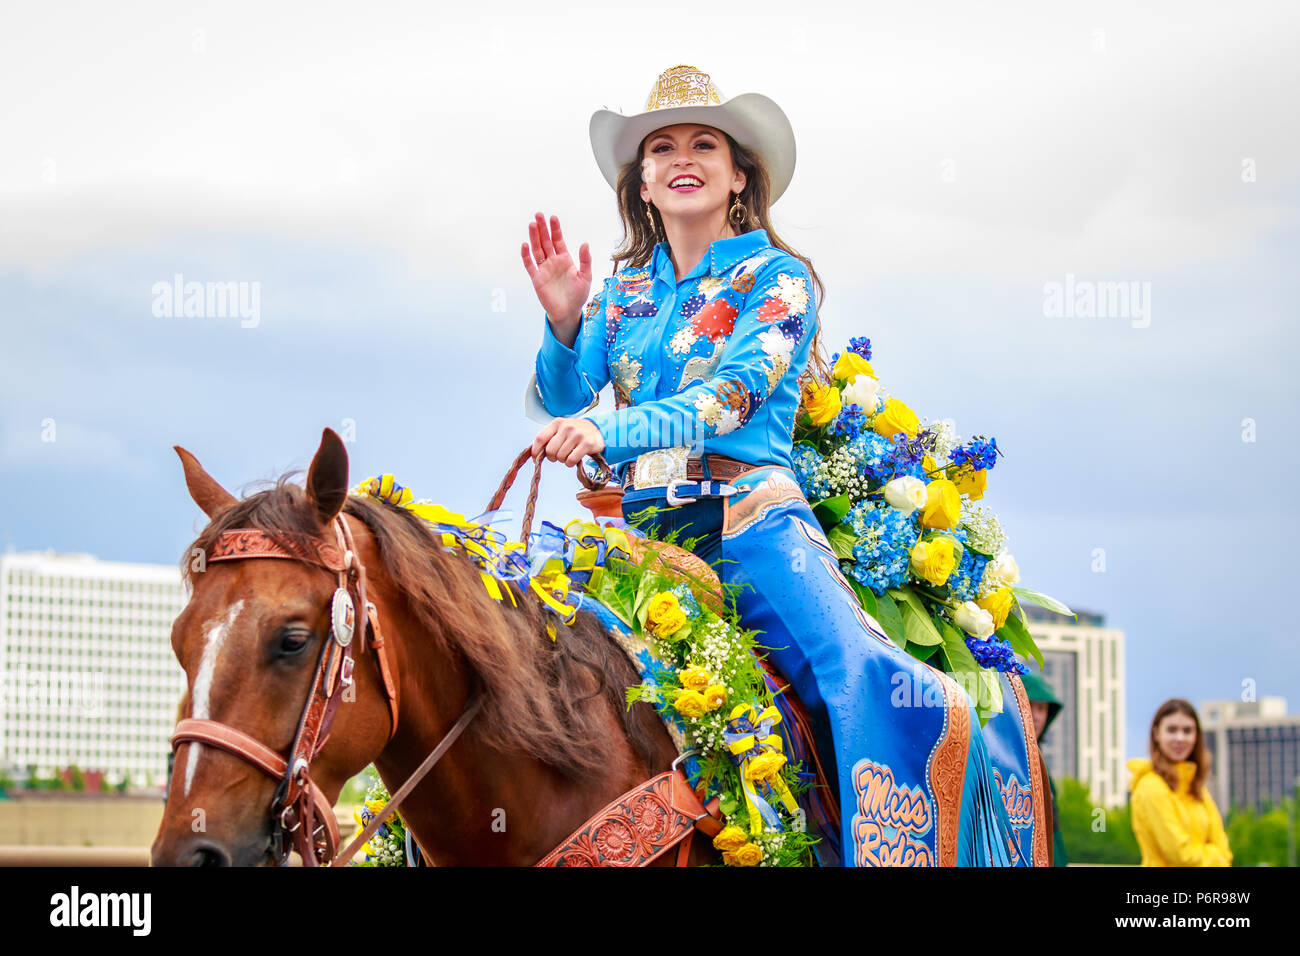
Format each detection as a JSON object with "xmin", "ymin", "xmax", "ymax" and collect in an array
[{"xmin": 793, "ymin": 337, "xmax": 1073, "ymax": 722}]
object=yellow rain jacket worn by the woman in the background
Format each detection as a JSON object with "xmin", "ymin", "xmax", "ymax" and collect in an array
[{"xmin": 1127, "ymin": 760, "xmax": 1232, "ymax": 866}]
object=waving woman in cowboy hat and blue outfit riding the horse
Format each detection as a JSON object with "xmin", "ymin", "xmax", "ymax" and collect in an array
[{"xmin": 521, "ymin": 66, "xmax": 1017, "ymax": 865}]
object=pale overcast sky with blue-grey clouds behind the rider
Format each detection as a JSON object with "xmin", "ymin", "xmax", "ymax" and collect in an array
[{"xmin": 0, "ymin": 3, "xmax": 1300, "ymax": 754}]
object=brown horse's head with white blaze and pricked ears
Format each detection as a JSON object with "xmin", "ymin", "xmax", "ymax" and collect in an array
[{"xmin": 152, "ymin": 429, "xmax": 393, "ymax": 866}]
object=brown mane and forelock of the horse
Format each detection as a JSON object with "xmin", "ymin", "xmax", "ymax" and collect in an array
[{"xmin": 181, "ymin": 472, "xmax": 659, "ymax": 779}]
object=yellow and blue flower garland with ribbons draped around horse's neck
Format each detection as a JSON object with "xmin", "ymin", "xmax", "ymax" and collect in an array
[{"xmin": 352, "ymin": 475, "xmax": 815, "ymax": 866}]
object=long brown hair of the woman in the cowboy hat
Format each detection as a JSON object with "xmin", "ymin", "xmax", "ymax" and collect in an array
[{"xmin": 611, "ymin": 127, "xmax": 831, "ymax": 382}]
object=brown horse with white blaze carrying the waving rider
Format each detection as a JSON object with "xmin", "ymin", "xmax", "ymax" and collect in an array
[{"xmin": 152, "ymin": 429, "xmax": 715, "ymax": 866}]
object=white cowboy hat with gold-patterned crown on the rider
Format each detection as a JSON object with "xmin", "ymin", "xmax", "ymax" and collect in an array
[{"xmin": 590, "ymin": 65, "xmax": 794, "ymax": 204}]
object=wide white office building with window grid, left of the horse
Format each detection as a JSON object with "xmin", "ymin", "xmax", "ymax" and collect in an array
[{"xmin": 0, "ymin": 551, "xmax": 187, "ymax": 786}]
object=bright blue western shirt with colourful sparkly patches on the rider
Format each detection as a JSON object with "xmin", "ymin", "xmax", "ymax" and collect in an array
[{"xmin": 527, "ymin": 229, "xmax": 816, "ymax": 475}]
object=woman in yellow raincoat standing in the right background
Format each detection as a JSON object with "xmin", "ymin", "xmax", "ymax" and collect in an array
[{"xmin": 1128, "ymin": 698, "xmax": 1232, "ymax": 866}]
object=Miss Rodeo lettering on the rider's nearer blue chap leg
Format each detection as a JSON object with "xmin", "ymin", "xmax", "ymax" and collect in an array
[{"xmin": 853, "ymin": 760, "xmax": 935, "ymax": 866}]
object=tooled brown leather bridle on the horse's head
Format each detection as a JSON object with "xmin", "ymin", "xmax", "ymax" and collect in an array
[{"xmin": 172, "ymin": 514, "xmax": 408, "ymax": 866}]
